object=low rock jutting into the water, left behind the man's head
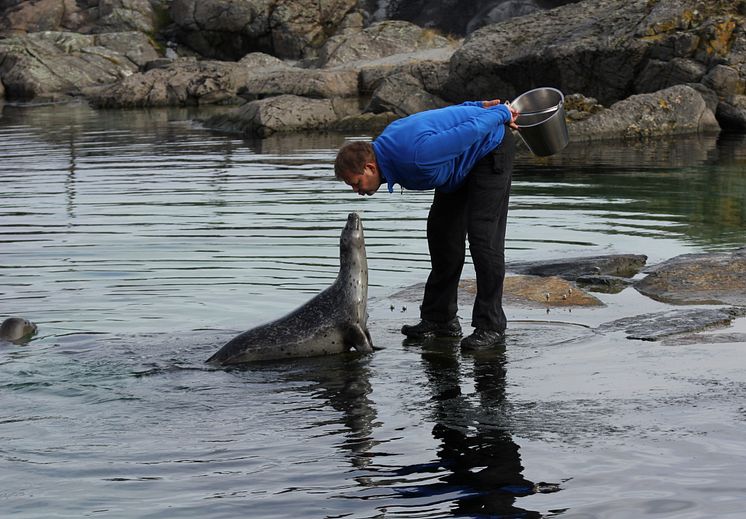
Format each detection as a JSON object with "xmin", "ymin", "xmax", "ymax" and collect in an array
[{"xmin": 204, "ymin": 95, "xmax": 359, "ymax": 137}]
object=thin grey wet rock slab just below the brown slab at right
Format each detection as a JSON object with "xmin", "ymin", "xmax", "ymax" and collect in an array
[{"xmin": 596, "ymin": 307, "xmax": 746, "ymax": 341}]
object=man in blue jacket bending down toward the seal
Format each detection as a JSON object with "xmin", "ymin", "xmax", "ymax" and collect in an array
[{"xmin": 334, "ymin": 99, "xmax": 518, "ymax": 349}]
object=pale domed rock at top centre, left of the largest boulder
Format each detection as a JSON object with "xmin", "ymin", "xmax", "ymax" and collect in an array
[{"xmin": 318, "ymin": 20, "xmax": 453, "ymax": 67}]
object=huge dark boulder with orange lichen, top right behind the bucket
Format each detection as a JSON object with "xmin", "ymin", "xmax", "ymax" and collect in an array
[{"xmin": 444, "ymin": 0, "xmax": 746, "ymax": 106}]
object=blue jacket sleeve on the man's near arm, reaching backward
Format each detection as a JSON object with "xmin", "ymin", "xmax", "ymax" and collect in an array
[{"xmin": 415, "ymin": 105, "xmax": 511, "ymax": 166}]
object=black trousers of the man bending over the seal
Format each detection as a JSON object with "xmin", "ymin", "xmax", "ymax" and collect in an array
[{"xmin": 420, "ymin": 132, "xmax": 515, "ymax": 331}]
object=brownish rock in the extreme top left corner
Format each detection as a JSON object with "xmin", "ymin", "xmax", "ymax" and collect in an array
[{"xmin": 0, "ymin": 0, "xmax": 157, "ymax": 34}]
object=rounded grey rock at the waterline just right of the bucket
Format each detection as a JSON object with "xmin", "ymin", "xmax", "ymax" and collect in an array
[{"xmin": 568, "ymin": 85, "xmax": 720, "ymax": 141}]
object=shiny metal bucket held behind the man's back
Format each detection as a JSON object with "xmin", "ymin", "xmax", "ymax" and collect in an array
[{"xmin": 510, "ymin": 87, "xmax": 570, "ymax": 157}]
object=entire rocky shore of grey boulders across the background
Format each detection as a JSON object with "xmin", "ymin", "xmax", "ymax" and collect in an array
[{"xmin": 0, "ymin": 0, "xmax": 746, "ymax": 141}]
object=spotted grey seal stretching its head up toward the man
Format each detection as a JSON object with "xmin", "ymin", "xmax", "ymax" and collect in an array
[{"xmin": 207, "ymin": 213, "xmax": 373, "ymax": 365}]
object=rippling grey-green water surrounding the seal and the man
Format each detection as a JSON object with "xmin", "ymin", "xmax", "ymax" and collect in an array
[{"xmin": 0, "ymin": 105, "xmax": 746, "ymax": 518}]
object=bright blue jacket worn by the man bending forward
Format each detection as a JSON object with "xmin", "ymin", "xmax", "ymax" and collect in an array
[{"xmin": 373, "ymin": 101, "xmax": 510, "ymax": 192}]
